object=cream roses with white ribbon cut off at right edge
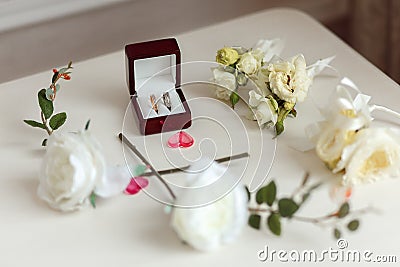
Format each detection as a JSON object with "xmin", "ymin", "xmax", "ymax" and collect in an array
[{"xmin": 308, "ymin": 79, "xmax": 400, "ymax": 186}]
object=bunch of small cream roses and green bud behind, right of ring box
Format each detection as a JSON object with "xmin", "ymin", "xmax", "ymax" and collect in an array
[{"xmin": 212, "ymin": 40, "xmax": 334, "ymax": 135}]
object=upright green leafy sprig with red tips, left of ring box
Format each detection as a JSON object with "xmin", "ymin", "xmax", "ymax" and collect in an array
[{"xmin": 24, "ymin": 62, "xmax": 72, "ymax": 146}]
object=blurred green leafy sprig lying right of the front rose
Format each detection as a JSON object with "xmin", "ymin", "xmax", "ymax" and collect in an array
[{"xmin": 248, "ymin": 173, "xmax": 367, "ymax": 238}]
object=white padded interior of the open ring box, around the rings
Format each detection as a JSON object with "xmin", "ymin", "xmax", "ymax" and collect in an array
[{"xmin": 134, "ymin": 54, "xmax": 185, "ymax": 119}]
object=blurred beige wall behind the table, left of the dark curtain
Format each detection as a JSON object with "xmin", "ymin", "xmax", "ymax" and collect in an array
[{"xmin": 0, "ymin": 0, "xmax": 348, "ymax": 82}]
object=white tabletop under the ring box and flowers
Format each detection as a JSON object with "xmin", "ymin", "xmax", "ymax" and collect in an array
[{"xmin": 0, "ymin": 9, "xmax": 400, "ymax": 267}]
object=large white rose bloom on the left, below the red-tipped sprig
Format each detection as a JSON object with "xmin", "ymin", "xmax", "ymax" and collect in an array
[{"xmin": 38, "ymin": 131, "xmax": 130, "ymax": 211}]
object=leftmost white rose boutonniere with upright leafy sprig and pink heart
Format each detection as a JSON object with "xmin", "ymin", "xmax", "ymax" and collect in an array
[{"xmin": 24, "ymin": 62, "xmax": 148, "ymax": 211}]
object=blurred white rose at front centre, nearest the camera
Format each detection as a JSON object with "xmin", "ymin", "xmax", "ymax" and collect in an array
[{"xmin": 171, "ymin": 162, "xmax": 248, "ymax": 251}]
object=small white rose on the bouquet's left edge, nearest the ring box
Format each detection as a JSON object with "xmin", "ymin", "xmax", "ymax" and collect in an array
[{"xmin": 213, "ymin": 68, "xmax": 237, "ymax": 100}]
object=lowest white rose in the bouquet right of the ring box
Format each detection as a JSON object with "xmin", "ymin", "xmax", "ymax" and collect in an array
[{"xmin": 249, "ymin": 90, "xmax": 278, "ymax": 126}]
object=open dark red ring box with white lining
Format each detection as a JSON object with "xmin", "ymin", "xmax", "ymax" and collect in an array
[{"xmin": 125, "ymin": 38, "xmax": 191, "ymax": 135}]
